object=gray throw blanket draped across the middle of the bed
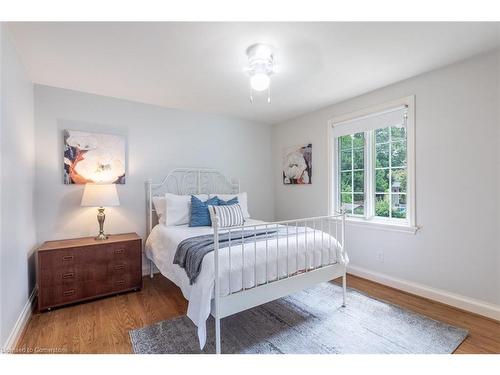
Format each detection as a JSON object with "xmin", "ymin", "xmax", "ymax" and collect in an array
[{"xmin": 174, "ymin": 227, "xmax": 292, "ymax": 284}]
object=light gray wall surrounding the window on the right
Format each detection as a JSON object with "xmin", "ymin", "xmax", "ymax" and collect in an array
[{"xmin": 272, "ymin": 53, "xmax": 500, "ymax": 305}]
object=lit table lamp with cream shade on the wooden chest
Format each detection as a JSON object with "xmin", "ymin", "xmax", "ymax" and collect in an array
[{"xmin": 81, "ymin": 184, "xmax": 120, "ymax": 240}]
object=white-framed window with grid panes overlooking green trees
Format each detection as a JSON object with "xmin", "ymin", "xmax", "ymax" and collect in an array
[{"xmin": 329, "ymin": 97, "xmax": 415, "ymax": 232}]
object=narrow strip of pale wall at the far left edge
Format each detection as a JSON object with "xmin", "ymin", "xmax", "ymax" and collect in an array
[{"xmin": 0, "ymin": 24, "xmax": 36, "ymax": 347}]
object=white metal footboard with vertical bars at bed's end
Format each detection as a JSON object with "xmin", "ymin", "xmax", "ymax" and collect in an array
[{"xmin": 212, "ymin": 212, "xmax": 348, "ymax": 353}]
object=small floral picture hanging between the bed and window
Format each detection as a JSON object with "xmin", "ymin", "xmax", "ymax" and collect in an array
[{"xmin": 283, "ymin": 143, "xmax": 312, "ymax": 185}]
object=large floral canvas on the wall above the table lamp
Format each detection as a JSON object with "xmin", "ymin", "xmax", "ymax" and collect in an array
[{"xmin": 64, "ymin": 130, "xmax": 126, "ymax": 184}]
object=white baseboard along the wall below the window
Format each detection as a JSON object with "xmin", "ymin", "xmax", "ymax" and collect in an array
[{"xmin": 347, "ymin": 266, "xmax": 500, "ymax": 321}]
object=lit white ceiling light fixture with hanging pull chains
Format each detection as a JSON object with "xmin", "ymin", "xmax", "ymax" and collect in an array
[{"xmin": 245, "ymin": 43, "xmax": 275, "ymax": 103}]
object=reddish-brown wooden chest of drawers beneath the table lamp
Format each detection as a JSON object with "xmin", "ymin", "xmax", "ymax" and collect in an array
[{"xmin": 37, "ymin": 233, "xmax": 142, "ymax": 311}]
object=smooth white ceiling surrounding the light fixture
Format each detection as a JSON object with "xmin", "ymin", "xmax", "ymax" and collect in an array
[{"xmin": 9, "ymin": 22, "xmax": 498, "ymax": 123}]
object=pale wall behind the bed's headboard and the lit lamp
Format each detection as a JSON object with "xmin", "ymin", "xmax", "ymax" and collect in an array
[{"xmin": 35, "ymin": 85, "xmax": 274, "ymax": 250}]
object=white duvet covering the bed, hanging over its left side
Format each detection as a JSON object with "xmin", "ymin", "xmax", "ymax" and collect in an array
[{"xmin": 145, "ymin": 219, "xmax": 342, "ymax": 348}]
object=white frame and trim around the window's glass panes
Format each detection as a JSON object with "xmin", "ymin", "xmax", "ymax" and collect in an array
[{"xmin": 328, "ymin": 95, "xmax": 418, "ymax": 233}]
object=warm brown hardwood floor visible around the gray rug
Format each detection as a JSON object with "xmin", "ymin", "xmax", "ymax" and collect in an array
[{"xmin": 17, "ymin": 274, "xmax": 500, "ymax": 353}]
